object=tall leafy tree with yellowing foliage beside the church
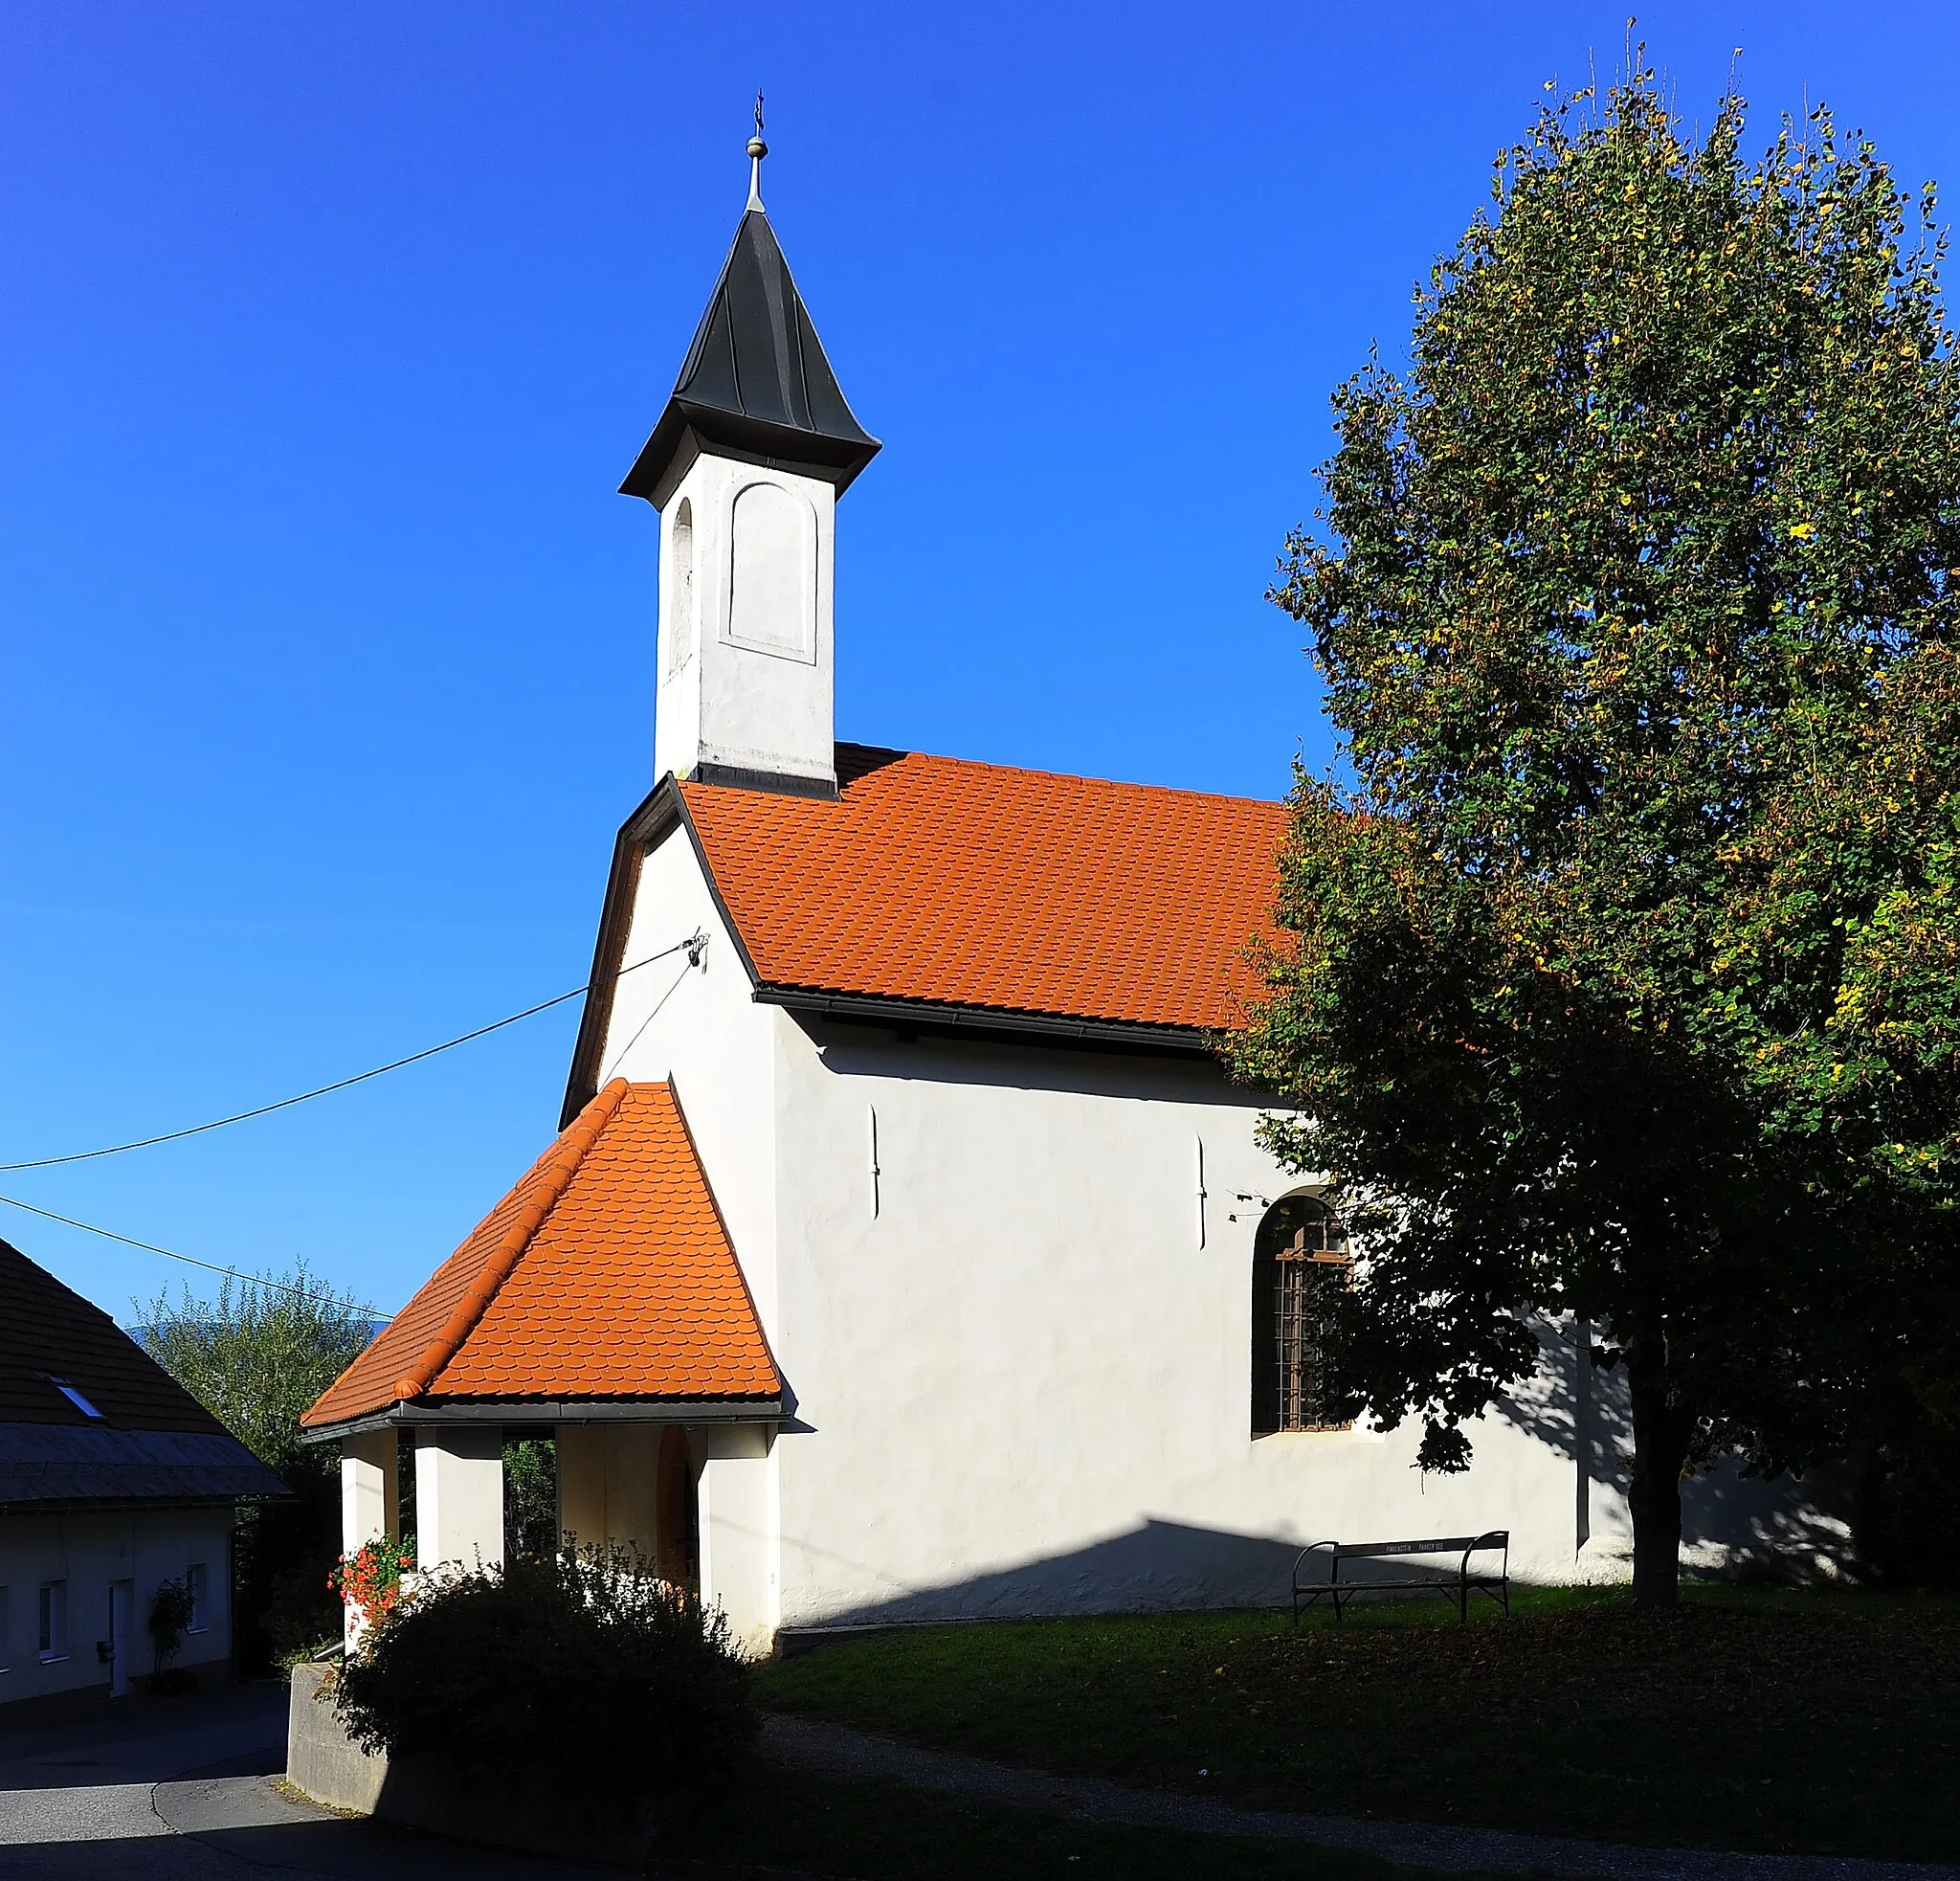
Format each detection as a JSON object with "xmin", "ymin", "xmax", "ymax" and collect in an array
[{"xmin": 1227, "ymin": 67, "xmax": 1960, "ymax": 1604}]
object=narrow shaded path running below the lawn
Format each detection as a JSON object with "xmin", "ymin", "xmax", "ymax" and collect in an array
[{"xmin": 763, "ymin": 1714, "xmax": 1960, "ymax": 1881}]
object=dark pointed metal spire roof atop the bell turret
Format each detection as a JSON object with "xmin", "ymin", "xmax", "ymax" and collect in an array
[{"xmin": 619, "ymin": 208, "xmax": 879, "ymax": 503}]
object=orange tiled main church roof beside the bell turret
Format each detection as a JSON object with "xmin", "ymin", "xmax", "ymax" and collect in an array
[{"xmin": 680, "ymin": 746, "xmax": 1285, "ymax": 1030}]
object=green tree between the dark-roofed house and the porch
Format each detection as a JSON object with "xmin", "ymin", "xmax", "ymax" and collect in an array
[{"xmin": 137, "ymin": 1262, "xmax": 372, "ymax": 1653}]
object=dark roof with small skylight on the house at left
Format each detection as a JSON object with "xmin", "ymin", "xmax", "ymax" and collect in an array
[{"xmin": 0, "ymin": 1242, "xmax": 286, "ymax": 1507}]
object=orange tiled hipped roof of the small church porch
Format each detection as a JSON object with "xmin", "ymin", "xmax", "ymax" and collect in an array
[{"xmin": 301, "ymin": 1079, "xmax": 782, "ymax": 1428}]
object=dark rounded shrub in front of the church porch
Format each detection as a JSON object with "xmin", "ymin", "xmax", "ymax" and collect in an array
[{"xmin": 335, "ymin": 1548, "xmax": 759, "ymax": 1810}]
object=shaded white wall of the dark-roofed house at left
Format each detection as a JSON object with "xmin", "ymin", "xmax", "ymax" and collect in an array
[{"xmin": 0, "ymin": 1509, "xmax": 232, "ymax": 1703}]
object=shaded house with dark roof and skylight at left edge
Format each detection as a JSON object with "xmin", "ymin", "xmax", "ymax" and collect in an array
[{"xmin": 0, "ymin": 1242, "xmax": 286, "ymax": 1703}]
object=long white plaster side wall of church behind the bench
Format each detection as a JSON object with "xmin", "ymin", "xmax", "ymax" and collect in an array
[{"xmin": 760, "ymin": 1014, "xmax": 1829, "ymax": 1626}]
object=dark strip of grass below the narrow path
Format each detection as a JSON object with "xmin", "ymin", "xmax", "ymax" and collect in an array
[{"xmin": 672, "ymin": 1765, "xmax": 1504, "ymax": 1881}]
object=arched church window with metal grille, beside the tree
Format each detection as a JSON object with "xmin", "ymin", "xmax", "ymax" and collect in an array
[{"xmin": 1253, "ymin": 1195, "xmax": 1352, "ymax": 1438}]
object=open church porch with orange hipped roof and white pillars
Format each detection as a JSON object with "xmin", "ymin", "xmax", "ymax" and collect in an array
[{"xmin": 301, "ymin": 1081, "xmax": 786, "ymax": 1649}]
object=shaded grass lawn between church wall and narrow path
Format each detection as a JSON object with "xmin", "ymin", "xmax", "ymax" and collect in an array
[{"xmin": 763, "ymin": 1589, "xmax": 1960, "ymax": 1873}]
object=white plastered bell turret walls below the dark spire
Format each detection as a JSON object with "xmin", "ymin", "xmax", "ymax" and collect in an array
[{"xmin": 653, "ymin": 453, "xmax": 836, "ymax": 781}]
